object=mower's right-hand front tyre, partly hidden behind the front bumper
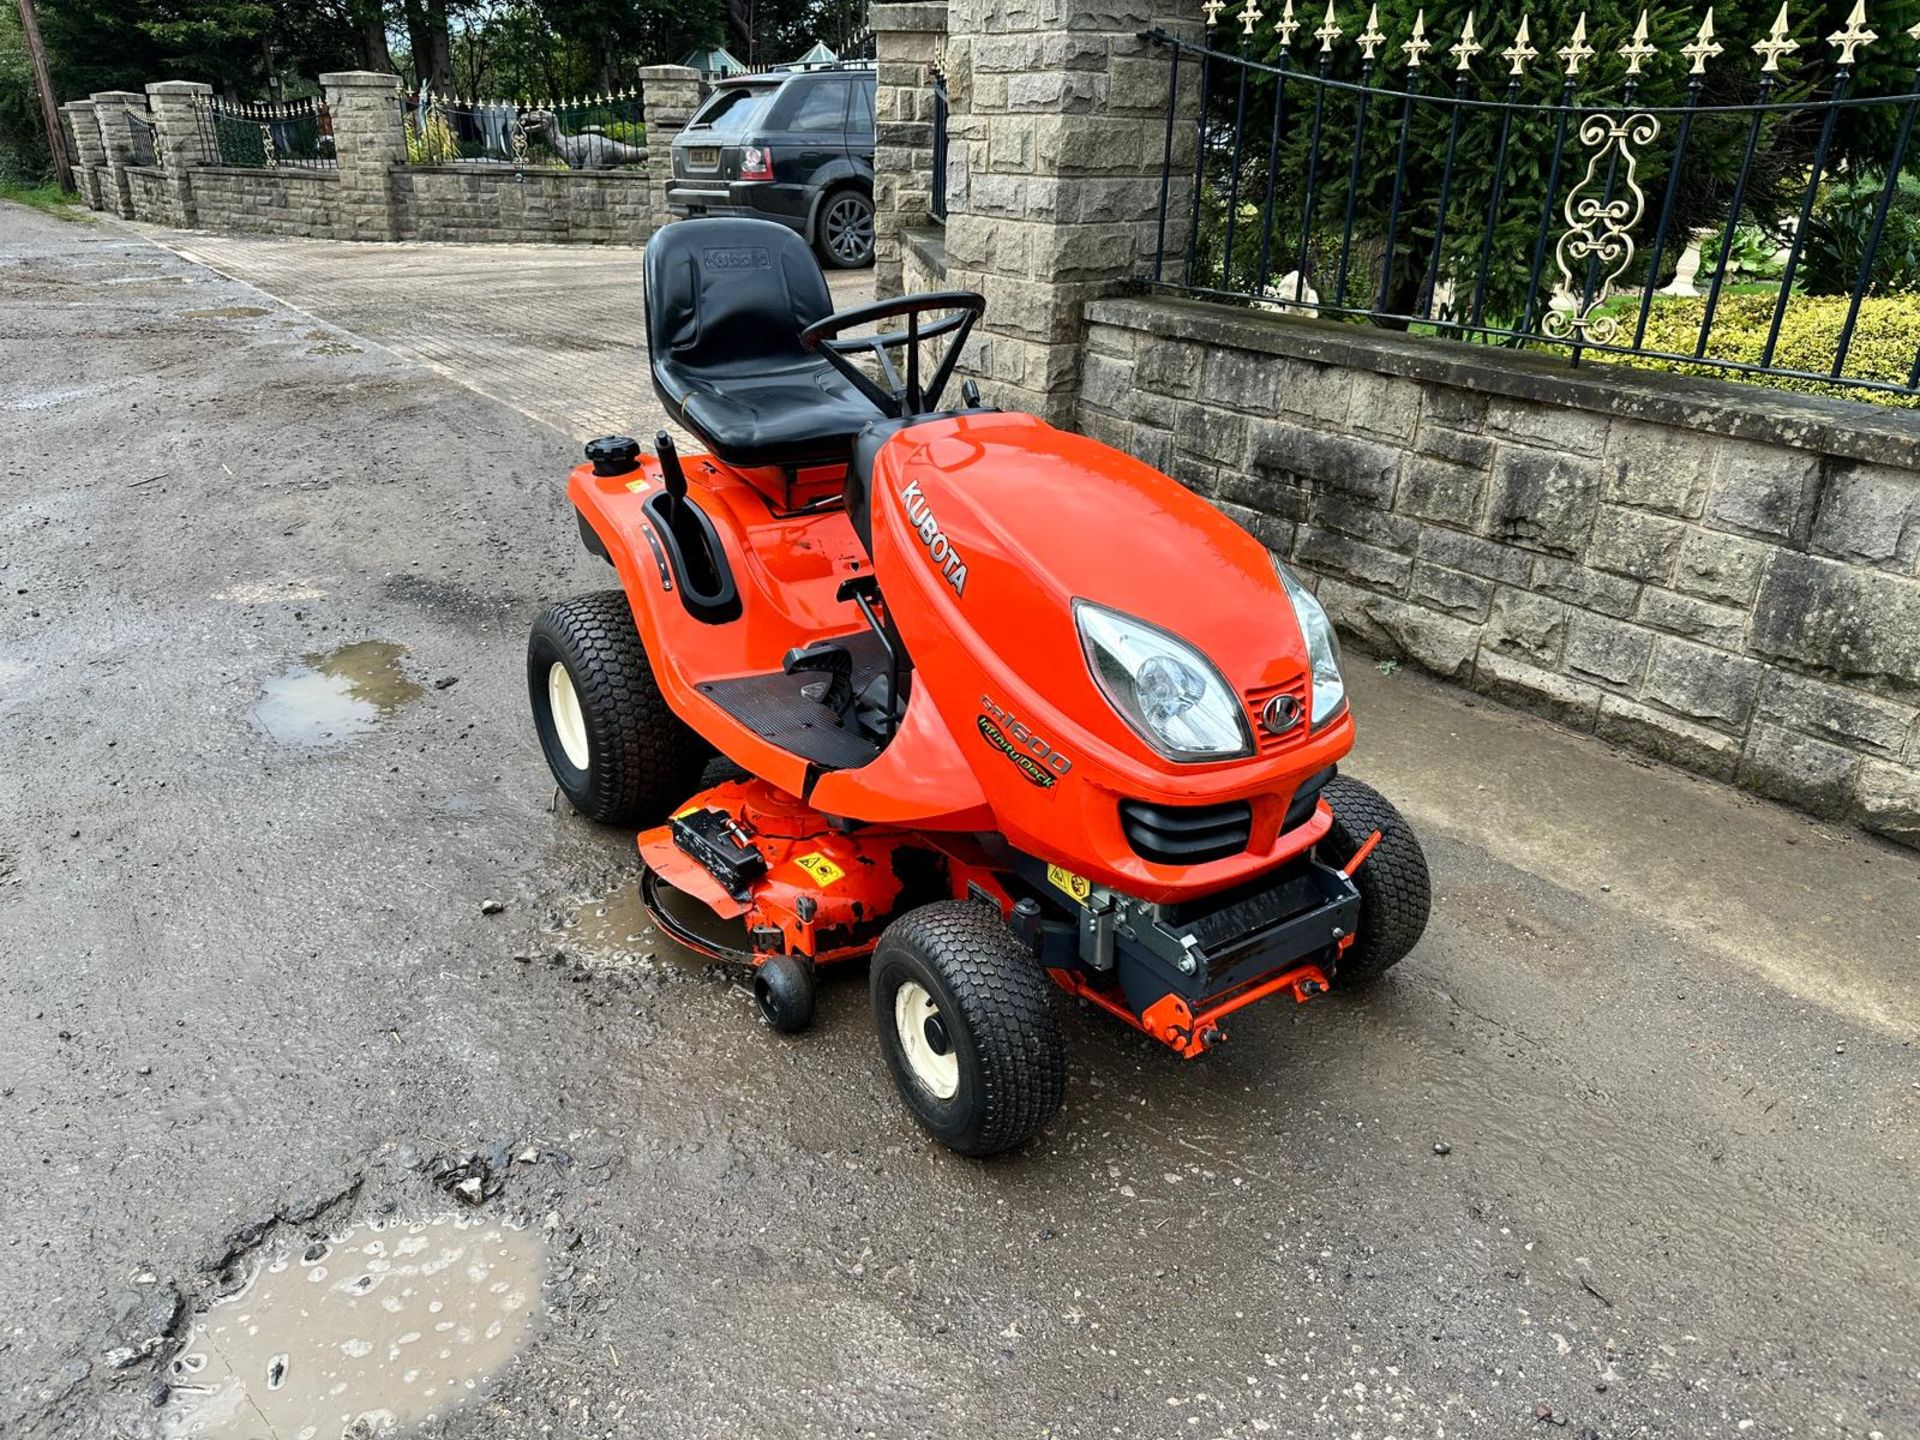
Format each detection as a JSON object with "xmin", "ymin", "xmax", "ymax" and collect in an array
[{"xmin": 1317, "ymin": 776, "xmax": 1432, "ymax": 991}]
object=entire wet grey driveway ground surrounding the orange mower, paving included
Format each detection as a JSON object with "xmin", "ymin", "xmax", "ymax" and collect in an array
[{"xmin": 11, "ymin": 205, "xmax": 1920, "ymax": 1440}]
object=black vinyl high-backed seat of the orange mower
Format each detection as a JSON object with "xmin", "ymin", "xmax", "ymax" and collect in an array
[{"xmin": 647, "ymin": 219, "xmax": 879, "ymax": 467}]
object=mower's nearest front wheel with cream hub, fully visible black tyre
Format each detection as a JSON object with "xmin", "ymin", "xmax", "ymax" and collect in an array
[{"xmin": 872, "ymin": 900, "xmax": 1066, "ymax": 1156}]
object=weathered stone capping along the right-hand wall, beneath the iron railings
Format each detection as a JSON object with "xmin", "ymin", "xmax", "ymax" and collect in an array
[{"xmin": 1087, "ymin": 296, "xmax": 1920, "ymax": 468}]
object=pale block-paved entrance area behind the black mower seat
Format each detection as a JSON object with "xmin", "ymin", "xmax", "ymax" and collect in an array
[{"xmin": 129, "ymin": 225, "xmax": 874, "ymax": 447}]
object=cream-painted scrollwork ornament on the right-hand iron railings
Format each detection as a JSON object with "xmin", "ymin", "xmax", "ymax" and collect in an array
[{"xmin": 1540, "ymin": 113, "xmax": 1661, "ymax": 346}]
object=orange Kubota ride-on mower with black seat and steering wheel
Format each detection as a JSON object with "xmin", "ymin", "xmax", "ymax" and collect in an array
[{"xmin": 528, "ymin": 219, "xmax": 1428, "ymax": 1156}]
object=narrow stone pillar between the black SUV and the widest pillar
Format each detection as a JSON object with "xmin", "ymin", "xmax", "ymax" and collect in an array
[{"xmin": 868, "ymin": 0, "xmax": 947, "ymax": 298}]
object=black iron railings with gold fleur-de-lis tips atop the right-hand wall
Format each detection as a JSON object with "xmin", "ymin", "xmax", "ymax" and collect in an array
[{"xmin": 1146, "ymin": 0, "xmax": 1920, "ymax": 403}]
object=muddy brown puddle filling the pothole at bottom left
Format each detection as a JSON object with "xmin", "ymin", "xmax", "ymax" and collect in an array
[{"xmin": 161, "ymin": 1215, "xmax": 545, "ymax": 1440}]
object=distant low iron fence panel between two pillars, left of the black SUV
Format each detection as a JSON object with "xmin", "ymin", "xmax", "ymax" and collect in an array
[{"xmin": 401, "ymin": 90, "xmax": 647, "ymax": 171}]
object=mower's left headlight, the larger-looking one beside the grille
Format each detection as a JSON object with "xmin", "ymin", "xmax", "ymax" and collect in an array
[{"xmin": 1073, "ymin": 601, "xmax": 1254, "ymax": 760}]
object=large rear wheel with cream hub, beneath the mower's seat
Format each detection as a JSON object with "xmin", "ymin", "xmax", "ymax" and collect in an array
[{"xmin": 526, "ymin": 589, "xmax": 712, "ymax": 826}]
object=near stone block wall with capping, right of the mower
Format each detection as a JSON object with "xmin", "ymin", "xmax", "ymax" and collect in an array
[{"xmin": 1079, "ymin": 298, "xmax": 1920, "ymax": 845}]
